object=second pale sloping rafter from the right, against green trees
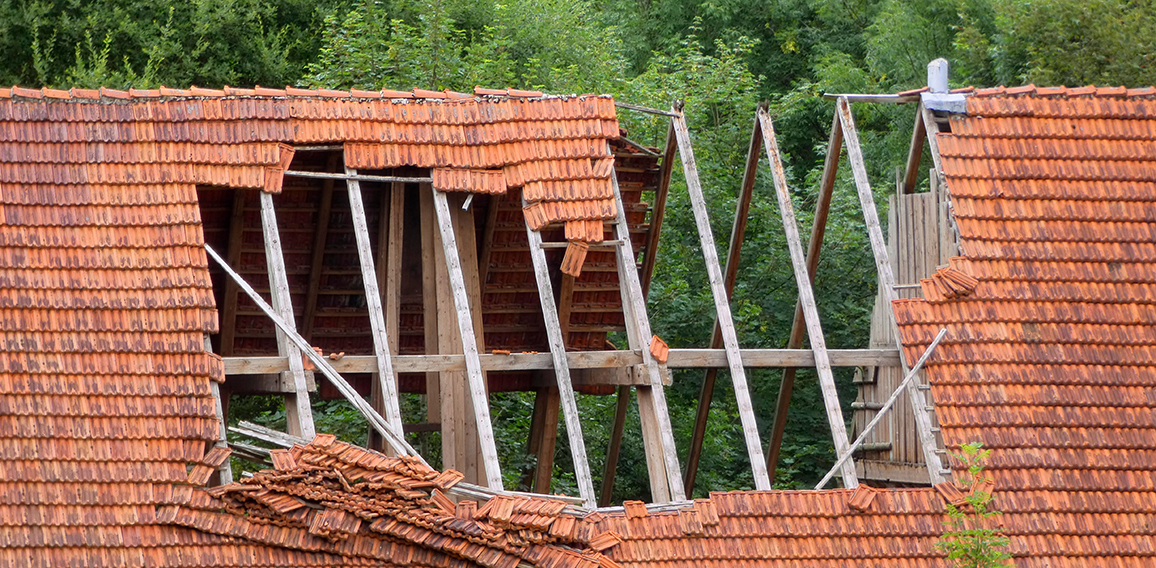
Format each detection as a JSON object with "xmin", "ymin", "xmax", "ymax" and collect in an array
[{"xmin": 758, "ymin": 109, "xmax": 859, "ymax": 488}]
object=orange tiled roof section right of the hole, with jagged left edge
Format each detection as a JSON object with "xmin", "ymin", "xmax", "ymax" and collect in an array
[{"xmin": 896, "ymin": 88, "xmax": 1156, "ymax": 567}]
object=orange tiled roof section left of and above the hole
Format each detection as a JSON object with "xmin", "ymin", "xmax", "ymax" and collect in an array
[{"xmin": 0, "ymin": 88, "xmax": 617, "ymax": 567}]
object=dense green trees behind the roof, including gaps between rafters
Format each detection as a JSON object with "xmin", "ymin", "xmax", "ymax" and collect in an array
[{"xmin": 11, "ymin": 0, "xmax": 1156, "ymax": 499}]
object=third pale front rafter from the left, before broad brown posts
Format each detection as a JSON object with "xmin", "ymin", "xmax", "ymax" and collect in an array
[{"xmin": 432, "ymin": 190, "xmax": 502, "ymax": 489}]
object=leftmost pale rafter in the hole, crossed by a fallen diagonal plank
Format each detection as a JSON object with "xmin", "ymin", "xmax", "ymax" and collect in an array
[{"xmin": 261, "ymin": 191, "xmax": 316, "ymax": 440}]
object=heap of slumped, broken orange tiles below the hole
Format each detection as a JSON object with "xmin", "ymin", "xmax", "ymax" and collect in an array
[{"xmin": 158, "ymin": 435, "xmax": 620, "ymax": 568}]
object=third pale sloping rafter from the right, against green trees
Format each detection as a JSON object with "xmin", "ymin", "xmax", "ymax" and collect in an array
[{"xmin": 670, "ymin": 115, "xmax": 771, "ymax": 490}]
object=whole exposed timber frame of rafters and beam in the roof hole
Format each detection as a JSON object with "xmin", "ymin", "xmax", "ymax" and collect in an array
[{"xmin": 206, "ymin": 87, "xmax": 946, "ymax": 509}]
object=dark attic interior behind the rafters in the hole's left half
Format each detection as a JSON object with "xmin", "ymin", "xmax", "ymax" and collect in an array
[{"xmin": 198, "ymin": 141, "xmax": 662, "ymax": 499}]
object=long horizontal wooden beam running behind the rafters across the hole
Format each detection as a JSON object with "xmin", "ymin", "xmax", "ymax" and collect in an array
[{"xmin": 224, "ymin": 349, "xmax": 899, "ymax": 377}]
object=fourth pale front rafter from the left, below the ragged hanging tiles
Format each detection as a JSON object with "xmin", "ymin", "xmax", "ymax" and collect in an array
[{"xmin": 523, "ymin": 220, "xmax": 595, "ymax": 508}]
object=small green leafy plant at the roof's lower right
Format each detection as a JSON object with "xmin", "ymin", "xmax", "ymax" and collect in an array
[{"xmin": 935, "ymin": 442, "xmax": 1015, "ymax": 568}]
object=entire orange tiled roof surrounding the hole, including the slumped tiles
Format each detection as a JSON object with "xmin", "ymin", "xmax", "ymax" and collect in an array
[{"xmin": 0, "ymin": 82, "xmax": 1156, "ymax": 568}]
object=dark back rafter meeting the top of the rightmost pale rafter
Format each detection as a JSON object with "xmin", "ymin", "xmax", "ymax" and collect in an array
[{"xmin": 767, "ymin": 109, "xmax": 843, "ymax": 475}]
